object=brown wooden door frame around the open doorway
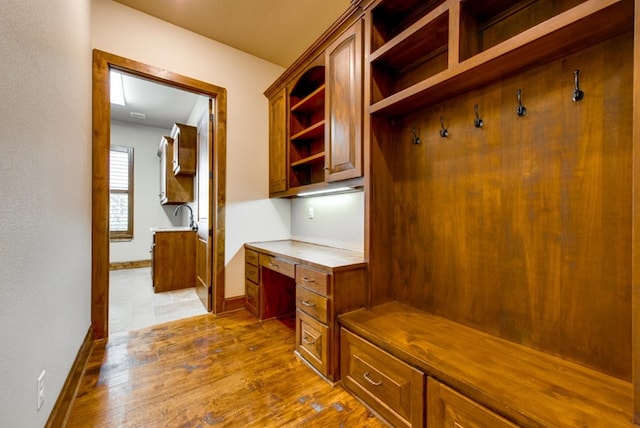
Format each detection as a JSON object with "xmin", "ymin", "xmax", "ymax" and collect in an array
[{"xmin": 91, "ymin": 49, "xmax": 227, "ymax": 340}]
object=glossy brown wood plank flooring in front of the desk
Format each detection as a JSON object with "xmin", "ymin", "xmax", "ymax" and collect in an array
[{"xmin": 66, "ymin": 310, "xmax": 386, "ymax": 427}]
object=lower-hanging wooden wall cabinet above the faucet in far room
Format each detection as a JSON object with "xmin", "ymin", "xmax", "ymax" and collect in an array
[{"xmin": 158, "ymin": 136, "xmax": 194, "ymax": 205}]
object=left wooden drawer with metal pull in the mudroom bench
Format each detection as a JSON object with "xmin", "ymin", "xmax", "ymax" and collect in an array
[{"xmin": 340, "ymin": 328, "xmax": 424, "ymax": 428}]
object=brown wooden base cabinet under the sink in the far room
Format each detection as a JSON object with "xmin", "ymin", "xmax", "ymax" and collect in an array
[{"xmin": 151, "ymin": 230, "xmax": 196, "ymax": 293}]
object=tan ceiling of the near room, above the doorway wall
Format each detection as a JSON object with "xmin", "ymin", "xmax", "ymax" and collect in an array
[{"xmin": 110, "ymin": 0, "xmax": 351, "ymax": 68}]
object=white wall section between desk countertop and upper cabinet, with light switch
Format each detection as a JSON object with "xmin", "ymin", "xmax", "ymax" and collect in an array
[{"xmin": 291, "ymin": 192, "xmax": 364, "ymax": 251}]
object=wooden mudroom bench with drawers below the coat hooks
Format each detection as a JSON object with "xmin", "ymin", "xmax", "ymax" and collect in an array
[{"xmin": 339, "ymin": 302, "xmax": 634, "ymax": 428}]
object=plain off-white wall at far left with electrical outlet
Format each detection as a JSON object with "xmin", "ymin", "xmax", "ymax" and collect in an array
[{"xmin": 0, "ymin": 0, "xmax": 91, "ymax": 427}]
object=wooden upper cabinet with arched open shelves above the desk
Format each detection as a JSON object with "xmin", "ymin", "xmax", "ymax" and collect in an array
[{"xmin": 265, "ymin": 6, "xmax": 364, "ymax": 197}]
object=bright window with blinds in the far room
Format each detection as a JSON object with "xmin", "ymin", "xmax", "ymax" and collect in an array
[{"xmin": 109, "ymin": 146, "xmax": 133, "ymax": 239}]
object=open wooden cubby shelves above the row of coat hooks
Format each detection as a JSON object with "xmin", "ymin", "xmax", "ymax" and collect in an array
[{"xmin": 369, "ymin": 0, "xmax": 633, "ymax": 116}]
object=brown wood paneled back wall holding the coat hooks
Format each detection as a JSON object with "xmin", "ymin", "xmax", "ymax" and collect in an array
[{"xmin": 370, "ymin": 33, "xmax": 633, "ymax": 380}]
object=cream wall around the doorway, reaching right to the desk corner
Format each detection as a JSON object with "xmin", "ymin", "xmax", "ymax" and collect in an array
[{"xmin": 91, "ymin": 0, "xmax": 290, "ymax": 297}]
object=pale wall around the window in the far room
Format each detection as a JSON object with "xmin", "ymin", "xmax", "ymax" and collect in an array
[{"xmin": 109, "ymin": 121, "xmax": 193, "ymax": 262}]
